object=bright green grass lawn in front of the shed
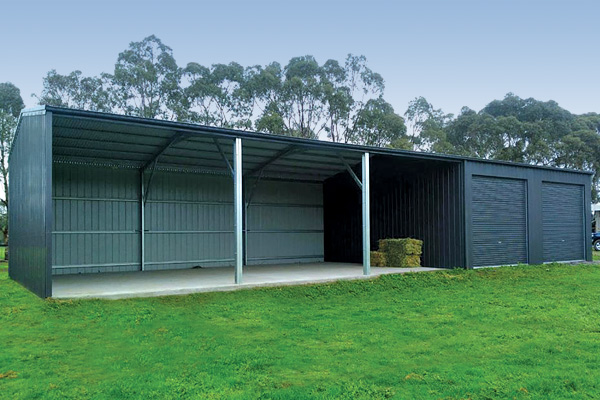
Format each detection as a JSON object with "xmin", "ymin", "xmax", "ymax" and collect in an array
[{"xmin": 0, "ymin": 264, "xmax": 600, "ymax": 399}]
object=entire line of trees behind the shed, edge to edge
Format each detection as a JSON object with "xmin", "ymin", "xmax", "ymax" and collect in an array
[{"xmin": 0, "ymin": 36, "xmax": 600, "ymax": 205}]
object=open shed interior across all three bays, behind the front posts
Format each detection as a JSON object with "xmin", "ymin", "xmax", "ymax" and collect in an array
[{"xmin": 52, "ymin": 114, "xmax": 464, "ymax": 275}]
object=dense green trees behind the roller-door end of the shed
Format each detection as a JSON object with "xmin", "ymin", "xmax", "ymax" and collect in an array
[{"xmin": 412, "ymin": 93, "xmax": 600, "ymax": 199}]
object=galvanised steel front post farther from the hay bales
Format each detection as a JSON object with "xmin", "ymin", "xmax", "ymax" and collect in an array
[{"xmin": 233, "ymin": 138, "xmax": 244, "ymax": 283}]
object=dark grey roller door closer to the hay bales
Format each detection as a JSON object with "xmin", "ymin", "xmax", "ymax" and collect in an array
[{"xmin": 472, "ymin": 176, "xmax": 527, "ymax": 267}]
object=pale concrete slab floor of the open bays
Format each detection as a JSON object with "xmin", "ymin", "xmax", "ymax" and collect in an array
[{"xmin": 52, "ymin": 263, "xmax": 438, "ymax": 299}]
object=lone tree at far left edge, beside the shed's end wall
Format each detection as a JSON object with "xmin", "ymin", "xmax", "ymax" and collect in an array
[{"xmin": 0, "ymin": 82, "xmax": 25, "ymax": 243}]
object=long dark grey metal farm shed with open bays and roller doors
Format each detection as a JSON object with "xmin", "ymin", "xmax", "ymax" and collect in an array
[{"xmin": 9, "ymin": 106, "xmax": 591, "ymax": 297}]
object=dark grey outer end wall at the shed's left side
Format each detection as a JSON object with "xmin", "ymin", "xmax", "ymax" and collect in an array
[{"xmin": 8, "ymin": 111, "xmax": 52, "ymax": 297}]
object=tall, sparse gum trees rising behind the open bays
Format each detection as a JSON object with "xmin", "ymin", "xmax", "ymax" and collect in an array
[{"xmin": 38, "ymin": 35, "xmax": 411, "ymax": 148}]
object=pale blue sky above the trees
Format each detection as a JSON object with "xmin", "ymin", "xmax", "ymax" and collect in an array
[{"xmin": 0, "ymin": 0, "xmax": 600, "ymax": 114}]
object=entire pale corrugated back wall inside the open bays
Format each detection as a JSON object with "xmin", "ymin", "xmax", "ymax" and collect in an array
[{"xmin": 52, "ymin": 163, "xmax": 323, "ymax": 274}]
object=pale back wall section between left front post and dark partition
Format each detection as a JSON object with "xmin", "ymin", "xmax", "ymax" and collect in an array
[{"xmin": 246, "ymin": 180, "xmax": 323, "ymax": 265}]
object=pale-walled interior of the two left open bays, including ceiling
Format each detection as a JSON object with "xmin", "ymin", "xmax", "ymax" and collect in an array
[{"xmin": 52, "ymin": 115, "xmax": 361, "ymax": 275}]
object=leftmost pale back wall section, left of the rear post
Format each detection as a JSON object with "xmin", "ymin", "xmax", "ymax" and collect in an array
[{"xmin": 52, "ymin": 163, "xmax": 140, "ymax": 275}]
